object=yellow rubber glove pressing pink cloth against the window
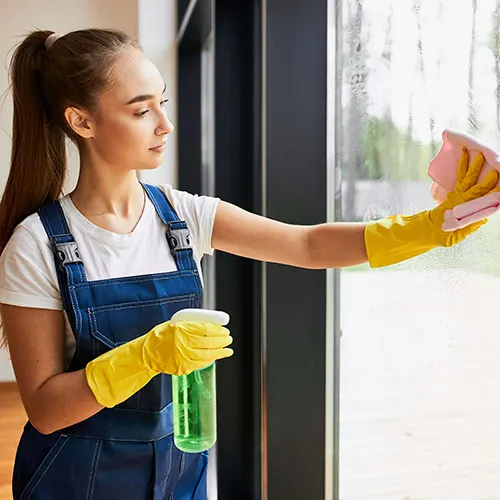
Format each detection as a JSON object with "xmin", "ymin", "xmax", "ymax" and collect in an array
[{"xmin": 365, "ymin": 148, "xmax": 498, "ymax": 267}]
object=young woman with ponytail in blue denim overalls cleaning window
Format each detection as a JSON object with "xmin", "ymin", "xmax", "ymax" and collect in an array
[{"xmin": 0, "ymin": 30, "xmax": 498, "ymax": 500}]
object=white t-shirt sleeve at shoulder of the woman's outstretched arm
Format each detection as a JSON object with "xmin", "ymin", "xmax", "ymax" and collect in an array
[{"xmin": 161, "ymin": 184, "xmax": 220, "ymax": 259}]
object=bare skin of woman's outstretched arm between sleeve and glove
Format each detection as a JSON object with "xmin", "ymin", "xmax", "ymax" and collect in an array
[{"xmin": 212, "ymin": 201, "xmax": 367, "ymax": 269}]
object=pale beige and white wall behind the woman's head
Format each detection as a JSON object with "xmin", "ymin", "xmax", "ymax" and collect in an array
[{"xmin": 0, "ymin": 0, "xmax": 177, "ymax": 381}]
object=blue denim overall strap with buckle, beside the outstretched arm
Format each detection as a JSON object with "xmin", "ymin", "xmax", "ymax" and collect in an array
[{"xmin": 143, "ymin": 184, "xmax": 196, "ymax": 271}]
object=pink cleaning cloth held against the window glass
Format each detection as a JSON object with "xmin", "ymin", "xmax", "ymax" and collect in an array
[{"xmin": 428, "ymin": 129, "xmax": 500, "ymax": 231}]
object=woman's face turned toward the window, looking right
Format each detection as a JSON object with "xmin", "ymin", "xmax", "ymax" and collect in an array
[{"xmin": 81, "ymin": 48, "xmax": 174, "ymax": 170}]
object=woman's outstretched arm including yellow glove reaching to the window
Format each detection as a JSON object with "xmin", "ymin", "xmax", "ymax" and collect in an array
[{"xmin": 212, "ymin": 148, "xmax": 500, "ymax": 269}]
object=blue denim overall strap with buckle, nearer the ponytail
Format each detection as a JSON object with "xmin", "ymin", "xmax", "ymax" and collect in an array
[{"xmin": 38, "ymin": 200, "xmax": 87, "ymax": 320}]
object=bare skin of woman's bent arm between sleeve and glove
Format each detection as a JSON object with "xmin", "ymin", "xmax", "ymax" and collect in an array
[{"xmin": 1, "ymin": 304, "xmax": 103, "ymax": 434}]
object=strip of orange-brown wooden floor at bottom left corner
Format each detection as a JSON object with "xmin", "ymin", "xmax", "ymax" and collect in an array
[{"xmin": 0, "ymin": 383, "xmax": 26, "ymax": 500}]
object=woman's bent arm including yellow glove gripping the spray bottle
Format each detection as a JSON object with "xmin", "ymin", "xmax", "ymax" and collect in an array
[{"xmin": 1, "ymin": 304, "xmax": 233, "ymax": 434}]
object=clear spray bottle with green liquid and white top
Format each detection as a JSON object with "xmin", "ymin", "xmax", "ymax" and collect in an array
[{"xmin": 171, "ymin": 309, "xmax": 229, "ymax": 453}]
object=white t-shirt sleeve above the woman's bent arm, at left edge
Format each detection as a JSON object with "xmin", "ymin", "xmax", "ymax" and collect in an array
[{"xmin": 0, "ymin": 226, "xmax": 63, "ymax": 310}]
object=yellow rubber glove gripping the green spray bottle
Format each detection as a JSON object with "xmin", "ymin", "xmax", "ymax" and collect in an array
[{"xmin": 85, "ymin": 321, "xmax": 233, "ymax": 408}]
